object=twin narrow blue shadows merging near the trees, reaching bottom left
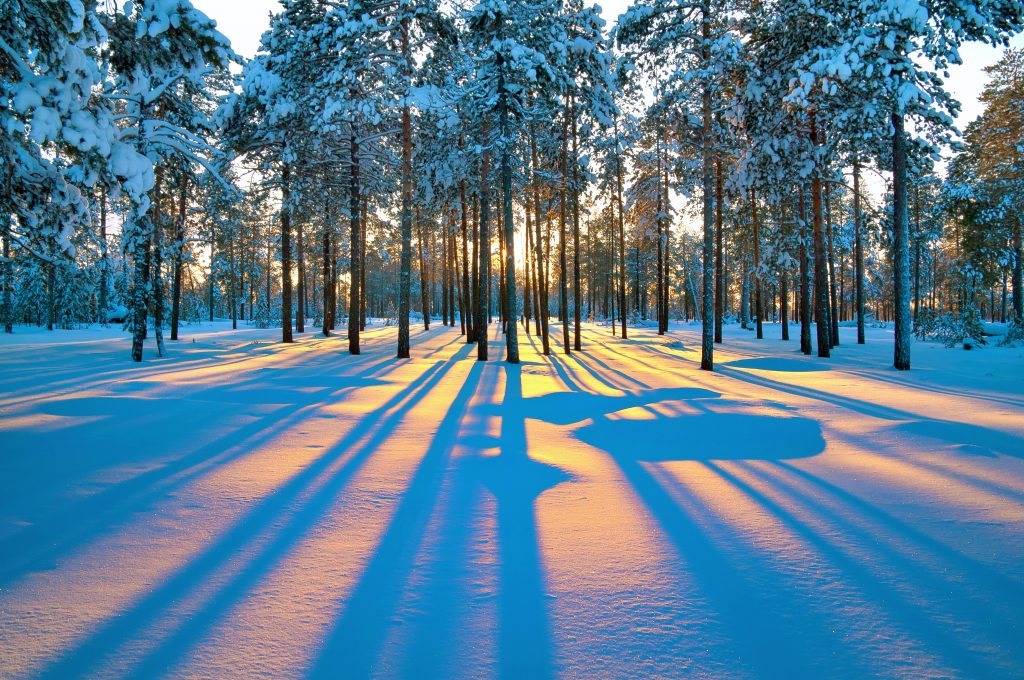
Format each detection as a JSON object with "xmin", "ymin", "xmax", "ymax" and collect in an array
[{"xmin": 42, "ymin": 349, "xmax": 468, "ymax": 678}]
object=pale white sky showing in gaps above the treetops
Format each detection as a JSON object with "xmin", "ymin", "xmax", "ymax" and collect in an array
[{"xmin": 193, "ymin": 0, "xmax": 1024, "ymax": 130}]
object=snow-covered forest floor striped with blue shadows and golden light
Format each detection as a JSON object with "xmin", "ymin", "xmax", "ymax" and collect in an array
[{"xmin": 0, "ymin": 324, "xmax": 1024, "ymax": 678}]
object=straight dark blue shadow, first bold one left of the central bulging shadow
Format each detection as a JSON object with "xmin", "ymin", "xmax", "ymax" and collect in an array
[{"xmin": 308, "ymin": 356, "xmax": 488, "ymax": 678}]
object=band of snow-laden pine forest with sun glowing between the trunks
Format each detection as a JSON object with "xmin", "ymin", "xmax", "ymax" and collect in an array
[{"xmin": 6, "ymin": 0, "xmax": 1024, "ymax": 370}]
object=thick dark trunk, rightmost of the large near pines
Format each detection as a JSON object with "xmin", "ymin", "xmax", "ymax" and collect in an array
[{"xmin": 892, "ymin": 113, "xmax": 910, "ymax": 371}]
